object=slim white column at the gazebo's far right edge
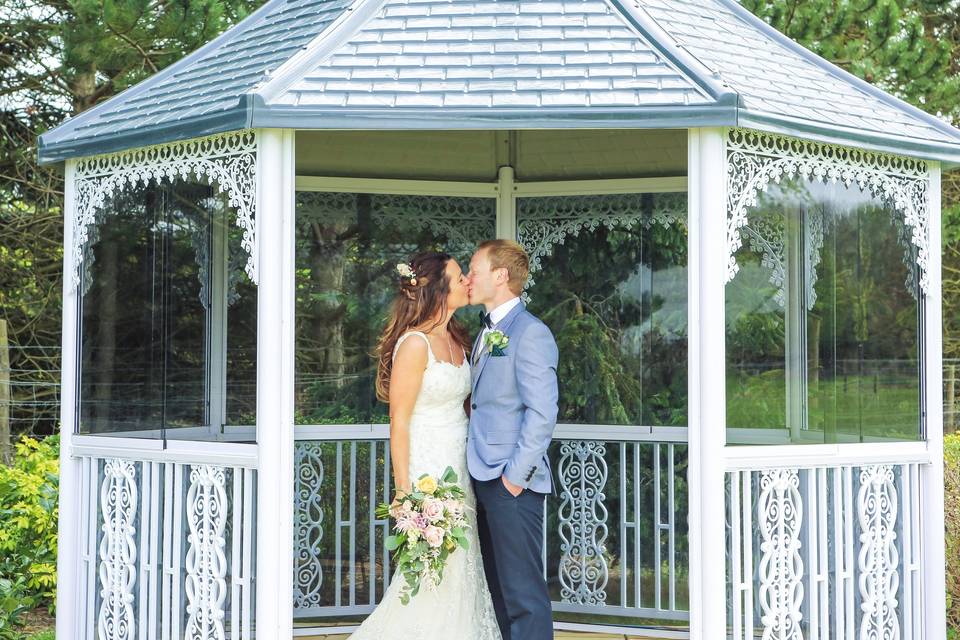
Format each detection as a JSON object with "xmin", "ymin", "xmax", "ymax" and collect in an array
[{"xmin": 920, "ymin": 163, "xmax": 947, "ymax": 640}]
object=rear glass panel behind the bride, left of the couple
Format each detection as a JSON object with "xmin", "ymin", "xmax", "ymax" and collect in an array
[{"xmin": 296, "ymin": 192, "xmax": 496, "ymax": 424}]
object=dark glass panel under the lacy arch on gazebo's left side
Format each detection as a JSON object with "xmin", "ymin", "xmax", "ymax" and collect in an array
[{"xmin": 79, "ymin": 181, "xmax": 256, "ymax": 439}]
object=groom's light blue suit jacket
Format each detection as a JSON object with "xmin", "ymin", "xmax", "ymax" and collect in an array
[{"xmin": 467, "ymin": 303, "xmax": 558, "ymax": 493}]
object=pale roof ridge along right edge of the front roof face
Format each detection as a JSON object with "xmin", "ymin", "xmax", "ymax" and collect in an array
[{"xmin": 607, "ymin": 0, "xmax": 740, "ymax": 105}]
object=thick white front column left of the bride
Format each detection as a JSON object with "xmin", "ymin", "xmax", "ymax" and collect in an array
[{"xmin": 255, "ymin": 129, "xmax": 295, "ymax": 640}]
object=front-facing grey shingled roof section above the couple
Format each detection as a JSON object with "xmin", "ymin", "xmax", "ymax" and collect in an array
[{"xmin": 269, "ymin": 0, "xmax": 715, "ymax": 109}]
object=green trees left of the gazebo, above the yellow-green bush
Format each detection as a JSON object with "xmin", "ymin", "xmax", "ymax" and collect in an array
[{"xmin": 0, "ymin": 0, "xmax": 260, "ymax": 431}]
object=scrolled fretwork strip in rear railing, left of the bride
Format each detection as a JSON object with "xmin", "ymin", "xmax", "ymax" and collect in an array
[{"xmin": 293, "ymin": 441, "xmax": 323, "ymax": 609}]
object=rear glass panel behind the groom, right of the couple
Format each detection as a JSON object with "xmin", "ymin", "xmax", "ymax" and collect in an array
[{"xmin": 517, "ymin": 193, "xmax": 687, "ymax": 426}]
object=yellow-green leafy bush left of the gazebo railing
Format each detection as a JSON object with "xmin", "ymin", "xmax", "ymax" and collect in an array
[{"xmin": 0, "ymin": 436, "xmax": 60, "ymax": 640}]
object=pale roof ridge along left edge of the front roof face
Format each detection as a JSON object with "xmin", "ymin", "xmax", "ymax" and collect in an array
[{"xmin": 260, "ymin": 0, "xmax": 387, "ymax": 103}]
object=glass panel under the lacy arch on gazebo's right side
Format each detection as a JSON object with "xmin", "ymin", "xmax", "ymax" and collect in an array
[{"xmin": 726, "ymin": 180, "xmax": 920, "ymax": 444}]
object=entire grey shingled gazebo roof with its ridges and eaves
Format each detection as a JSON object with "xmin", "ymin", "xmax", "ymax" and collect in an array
[{"xmin": 40, "ymin": 0, "xmax": 960, "ymax": 164}]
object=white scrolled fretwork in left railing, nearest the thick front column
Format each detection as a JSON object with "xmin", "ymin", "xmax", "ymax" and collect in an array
[{"xmin": 184, "ymin": 465, "xmax": 228, "ymax": 640}]
